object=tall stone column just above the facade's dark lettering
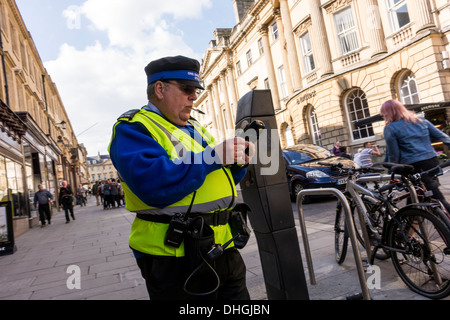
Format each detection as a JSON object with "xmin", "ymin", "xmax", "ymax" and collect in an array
[{"xmin": 307, "ymin": 0, "xmax": 334, "ymax": 77}]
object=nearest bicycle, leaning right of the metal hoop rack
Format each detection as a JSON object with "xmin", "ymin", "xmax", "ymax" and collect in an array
[{"xmin": 328, "ymin": 161, "xmax": 450, "ymax": 299}]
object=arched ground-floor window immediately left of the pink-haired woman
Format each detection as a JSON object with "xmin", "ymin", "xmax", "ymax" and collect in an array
[{"xmin": 345, "ymin": 89, "xmax": 374, "ymax": 140}]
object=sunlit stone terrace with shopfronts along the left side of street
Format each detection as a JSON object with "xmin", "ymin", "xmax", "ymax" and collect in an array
[{"xmin": 0, "ymin": 0, "xmax": 88, "ymax": 236}]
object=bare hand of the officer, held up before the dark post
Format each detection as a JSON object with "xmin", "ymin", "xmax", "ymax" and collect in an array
[{"xmin": 214, "ymin": 137, "xmax": 255, "ymax": 165}]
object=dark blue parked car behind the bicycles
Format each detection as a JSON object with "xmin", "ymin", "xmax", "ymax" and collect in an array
[{"xmin": 283, "ymin": 144, "xmax": 358, "ymax": 203}]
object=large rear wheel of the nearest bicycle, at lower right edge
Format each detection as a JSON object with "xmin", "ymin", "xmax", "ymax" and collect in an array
[{"xmin": 387, "ymin": 208, "xmax": 450, "ymax": 299}]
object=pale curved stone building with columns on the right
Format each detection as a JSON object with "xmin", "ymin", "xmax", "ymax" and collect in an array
[{"xmin": 196, "ymin": 0, "xmax": 450, "ymax": 160}]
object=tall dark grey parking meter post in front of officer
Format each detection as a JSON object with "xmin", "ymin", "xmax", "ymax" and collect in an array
[{"xmin": 236, "ymin": 90, "xmax": 309, "ymax": 300}]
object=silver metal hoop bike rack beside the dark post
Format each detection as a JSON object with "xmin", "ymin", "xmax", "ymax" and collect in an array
[{"xmin": 297, "ymin": 188, "xmax": 371, "ymax": 300}]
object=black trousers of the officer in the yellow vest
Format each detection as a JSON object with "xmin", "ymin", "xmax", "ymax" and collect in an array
[{"xmin": 136, "ymin": 248, "xmax": 250, "ymax": 300}]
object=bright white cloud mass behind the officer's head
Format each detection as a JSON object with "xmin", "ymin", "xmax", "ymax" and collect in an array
[{"xmin": 45, "ymin": 0, "xmax": 211, "ymax": 155}]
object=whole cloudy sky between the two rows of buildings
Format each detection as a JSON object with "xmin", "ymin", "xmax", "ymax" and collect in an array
[{"xmin": 16, "ymin": 0, "xmax": 236, "ymax": 156}]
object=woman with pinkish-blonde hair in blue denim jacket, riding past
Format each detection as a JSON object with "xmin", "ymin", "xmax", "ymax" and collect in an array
[{"xmin": 380, "ymin": 100, "xmax": 450, "ymax": 213}]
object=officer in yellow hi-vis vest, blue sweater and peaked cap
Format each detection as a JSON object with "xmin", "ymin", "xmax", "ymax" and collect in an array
[{"xmin": 109, "ymin": 56, "xmax": 255, "ymax": 299}]
